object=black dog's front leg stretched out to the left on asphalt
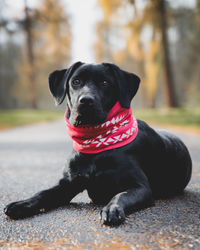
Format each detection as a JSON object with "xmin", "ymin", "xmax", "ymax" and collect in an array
[{"xmin": 4, "ymin": 178, "xmax": 84, "ymax": 219}]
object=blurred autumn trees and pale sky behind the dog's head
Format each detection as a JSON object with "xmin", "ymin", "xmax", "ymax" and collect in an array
[{"xmin": 0, "ymin": 0, "xmax": 200, "ymax": 129}]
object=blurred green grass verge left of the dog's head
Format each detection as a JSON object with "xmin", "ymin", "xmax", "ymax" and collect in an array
[{"xmin": 0, "ymin": 109, "xmax": 64, "ymax": 129}]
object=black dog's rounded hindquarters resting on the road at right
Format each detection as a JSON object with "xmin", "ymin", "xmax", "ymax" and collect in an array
[{"xmin": 151, "ymin": 130, "xmax": 192, "ymax": 198}]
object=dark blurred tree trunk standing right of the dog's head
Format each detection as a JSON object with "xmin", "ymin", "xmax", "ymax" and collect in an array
[{"xmin": 158, "ymin": 0, "xmax": 177, "ymax": 107}]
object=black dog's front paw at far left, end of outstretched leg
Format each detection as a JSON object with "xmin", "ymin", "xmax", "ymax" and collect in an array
[{"xmin": 4, "ymin": 201, "xmax": 36, "ymax": 220}]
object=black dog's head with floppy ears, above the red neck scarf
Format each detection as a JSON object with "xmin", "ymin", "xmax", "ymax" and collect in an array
[{"xmin": 49, "ymin": 62, "xmax": 140, "ymax": 126}]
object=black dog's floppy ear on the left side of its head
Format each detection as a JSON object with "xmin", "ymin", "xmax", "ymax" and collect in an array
[{"xmin": 49, "ymin": 62, "xmax": 83, "ymax": 105}]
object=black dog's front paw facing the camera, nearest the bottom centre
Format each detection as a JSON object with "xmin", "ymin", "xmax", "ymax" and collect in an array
[{"xmin": 100, "ymin": 204, "xmax": 125, "ymax": 226}]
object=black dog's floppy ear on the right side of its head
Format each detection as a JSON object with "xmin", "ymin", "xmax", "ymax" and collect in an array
[{"xmin": 103, "ymin": 63, "xmax": 140, "ymax": 108}]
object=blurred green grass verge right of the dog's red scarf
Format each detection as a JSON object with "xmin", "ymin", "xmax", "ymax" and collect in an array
[{"xmin": 134, "ymin": 108, "xmax": 200, "ymax": 132}]
